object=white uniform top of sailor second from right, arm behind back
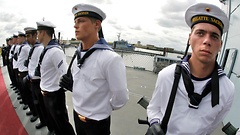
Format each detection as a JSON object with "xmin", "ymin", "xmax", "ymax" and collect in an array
[{"xmin": 72, "ymin": 39, "xmax": 129, "ymax": 120}]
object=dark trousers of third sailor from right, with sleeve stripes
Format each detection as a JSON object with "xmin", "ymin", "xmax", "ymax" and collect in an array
[{"xmin": 43, "ymin": 89, "xmax": 75, "ymax": 135}]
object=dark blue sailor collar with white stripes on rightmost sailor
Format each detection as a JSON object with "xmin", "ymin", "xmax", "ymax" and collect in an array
[{"xmin": 181, "ymin": 55, "xmax": 226, "ymax": 78}]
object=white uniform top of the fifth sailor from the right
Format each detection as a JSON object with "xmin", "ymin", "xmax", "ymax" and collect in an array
[{"xmin": 17, "ymin": 43, "xmax": 31, "ymax": 72}]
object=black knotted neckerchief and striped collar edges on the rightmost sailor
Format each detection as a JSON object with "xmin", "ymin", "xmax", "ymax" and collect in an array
[{"xmin": 181, "ymin": 56, "xmax": 225, "ymax": 109}]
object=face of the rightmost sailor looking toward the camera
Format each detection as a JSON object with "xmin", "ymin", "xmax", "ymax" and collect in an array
[{"xmin": 189, "ymin": 23, "xmax": 222, "ymax": 63}]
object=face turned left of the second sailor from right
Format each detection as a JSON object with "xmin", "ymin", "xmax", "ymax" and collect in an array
[{"xmin": 74, "ymin": 17, "xmax": 96, "ymax": 40}]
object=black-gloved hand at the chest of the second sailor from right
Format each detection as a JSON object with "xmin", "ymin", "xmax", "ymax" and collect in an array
[{"xmin": 59, "ymin": 74, "xmax": 73, "ymax": 91}]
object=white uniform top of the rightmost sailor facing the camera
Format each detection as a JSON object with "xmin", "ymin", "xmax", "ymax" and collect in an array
[{"xmin": 147, "ymin": 64, "xmax": 235, "ymax": 135}]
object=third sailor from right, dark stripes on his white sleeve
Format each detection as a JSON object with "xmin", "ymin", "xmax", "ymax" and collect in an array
[{"xmin": 35, "ymin": 21, "xmax": 75, "ymax": 135}]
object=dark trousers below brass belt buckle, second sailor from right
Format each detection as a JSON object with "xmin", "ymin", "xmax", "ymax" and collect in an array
[{"xmin": 73, "ymin": 111, "xmax": 111, "ymax": 135}]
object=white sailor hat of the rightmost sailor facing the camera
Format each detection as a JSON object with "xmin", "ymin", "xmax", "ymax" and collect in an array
[{"xmin": 185, "ymin": 3, "xmax": 229, "ymax": 34}]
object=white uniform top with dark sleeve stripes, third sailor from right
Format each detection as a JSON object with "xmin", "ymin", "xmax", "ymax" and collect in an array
[{"xmin": 40, "ymin": 44, "xmax": 68, "ymax": 92}]
